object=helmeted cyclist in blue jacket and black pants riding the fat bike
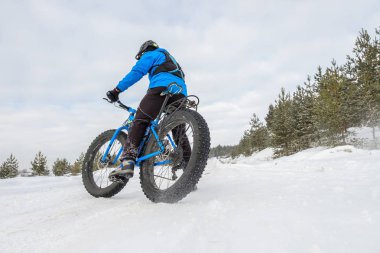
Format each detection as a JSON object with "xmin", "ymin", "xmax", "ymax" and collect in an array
[{"xmin": 107, "ymin": 40, "xmax": 187, "ymax": 179}]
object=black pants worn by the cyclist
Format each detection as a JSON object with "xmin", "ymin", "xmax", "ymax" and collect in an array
[{"xmin": 121, "ymin": 87, "xmax": 184, "ymax": 160}]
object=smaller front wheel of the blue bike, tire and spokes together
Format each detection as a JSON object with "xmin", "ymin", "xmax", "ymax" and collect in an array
[{"xmin": 82, "ymin": 130, "xmax": 128, "ymax": 198}]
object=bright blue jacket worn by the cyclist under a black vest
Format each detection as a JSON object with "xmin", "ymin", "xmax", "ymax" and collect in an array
[{"xmin": 117, "ymin": 48, "xmax": 187, "ymax": 96}]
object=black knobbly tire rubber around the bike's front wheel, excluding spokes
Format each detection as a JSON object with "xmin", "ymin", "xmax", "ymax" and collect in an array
[{"xmin": 82, "ymin": 129, "xmax": 128, "ymax": 198}]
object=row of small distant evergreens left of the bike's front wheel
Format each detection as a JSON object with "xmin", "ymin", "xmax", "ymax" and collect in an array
[{"xmin": 0, "ymin": 151, "xmax": 84, "ymax": 179}]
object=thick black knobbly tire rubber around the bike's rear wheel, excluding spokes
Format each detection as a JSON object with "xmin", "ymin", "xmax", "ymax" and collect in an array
[{"xmin": 140, "ymin": 109, "xmax": 210, "ymax": 203}]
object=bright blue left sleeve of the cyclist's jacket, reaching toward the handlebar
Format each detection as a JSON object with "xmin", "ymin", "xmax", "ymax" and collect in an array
[{"xmin": 116, "ymin": 52, "xmax": 156, "ymax": 91}]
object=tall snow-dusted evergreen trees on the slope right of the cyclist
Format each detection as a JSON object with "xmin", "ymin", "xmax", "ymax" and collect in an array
[{"xmin": 210, "ymin": 29, "xmax": 380, "ymax": 157}]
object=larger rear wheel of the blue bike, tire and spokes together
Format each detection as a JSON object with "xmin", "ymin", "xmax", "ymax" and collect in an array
[{"xmin": 140, "ymin": 109, "xmax": 210, "ymax": 203}]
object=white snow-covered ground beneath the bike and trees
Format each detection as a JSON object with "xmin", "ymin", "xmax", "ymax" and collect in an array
[{"xmin": 0, "ymin": 146, "xmax": 380, "ymax": 253}]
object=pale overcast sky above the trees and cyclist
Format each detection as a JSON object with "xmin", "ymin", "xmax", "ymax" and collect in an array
[{"xmin": 0, "ymin": 0, "xmax": 380, "ymax": 169}]
